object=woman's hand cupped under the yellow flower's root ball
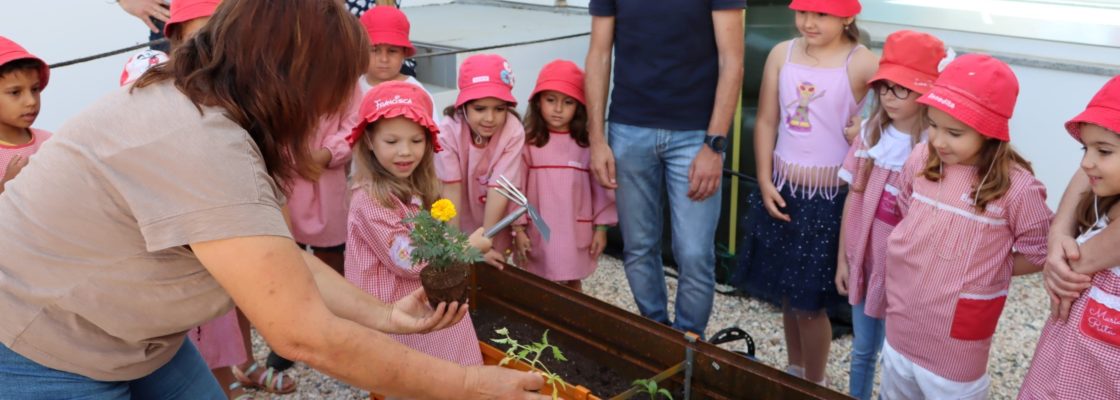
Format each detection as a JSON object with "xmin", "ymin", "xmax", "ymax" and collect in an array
[{"xmin": 384, "ymin": 288, "xmax": 469, "ymax": 335}]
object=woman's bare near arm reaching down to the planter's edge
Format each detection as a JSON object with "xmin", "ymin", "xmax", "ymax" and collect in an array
[{"xmin": 192, "ymin": 236, "xmax": 544, "ymax": 399}]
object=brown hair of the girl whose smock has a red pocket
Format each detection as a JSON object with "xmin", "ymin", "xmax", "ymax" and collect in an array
[{"xmin": 922, "ymin": 139, "xmax": 1035, "ymax": 213}]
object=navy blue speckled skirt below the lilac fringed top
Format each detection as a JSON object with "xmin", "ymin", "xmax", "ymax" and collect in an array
[{"xmin": 731, "ymin": 186, "xmax": 848, "ymax": 311}]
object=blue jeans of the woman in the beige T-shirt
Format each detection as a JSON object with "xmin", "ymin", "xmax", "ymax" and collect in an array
[{"xmin": 0, "ymin": 341, "xmax": 225, "ymax": 400}]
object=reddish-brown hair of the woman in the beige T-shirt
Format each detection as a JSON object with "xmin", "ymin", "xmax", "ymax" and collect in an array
[{"xmin": 132, "ymin": 0, "xmax": 370, "ymax": 183}]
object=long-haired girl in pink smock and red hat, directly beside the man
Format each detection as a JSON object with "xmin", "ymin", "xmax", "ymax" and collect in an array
[{"xmin": 514, "ymin": 59, "xmax": 618, "ymax": 290}]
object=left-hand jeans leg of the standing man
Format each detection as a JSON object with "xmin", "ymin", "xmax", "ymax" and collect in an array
[{"xmin": 608, "ymin": 122, "xmax": 669, "ymax": 324}]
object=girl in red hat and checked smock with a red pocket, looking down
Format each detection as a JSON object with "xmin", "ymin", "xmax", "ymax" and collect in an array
[{"xmin": 880, "ymin": 54, "xmax": 1053, "ymax": 399}]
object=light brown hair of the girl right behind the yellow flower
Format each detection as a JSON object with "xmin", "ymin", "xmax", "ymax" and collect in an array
[{"xmin": 353, "ymin": 122, "xmax": 440, "ymax": 208}]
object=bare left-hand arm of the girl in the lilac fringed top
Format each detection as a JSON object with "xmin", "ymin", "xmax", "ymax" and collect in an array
[{"xmin": 755, "ymin": 41, "xmax": 790, "ymax": 222}]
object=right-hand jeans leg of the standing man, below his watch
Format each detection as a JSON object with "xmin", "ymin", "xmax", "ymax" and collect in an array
[{"xmin": 662, "ymin": 130, "xmax": 721, "ymax": 337}]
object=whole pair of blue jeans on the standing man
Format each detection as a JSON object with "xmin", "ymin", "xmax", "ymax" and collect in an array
[{"xmin": 608, "ymin": 122, "xmax": 720, "ymax": 336}]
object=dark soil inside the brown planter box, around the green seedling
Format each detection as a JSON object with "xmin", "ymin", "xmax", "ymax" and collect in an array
[{"xmin": 470, "ymin": 308, "xmax": 643, "ymax": 399}]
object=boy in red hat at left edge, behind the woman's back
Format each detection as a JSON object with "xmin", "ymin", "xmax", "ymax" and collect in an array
[{"xmin": 0, "ymin": 36, "xmax": 50, "ymax": 194}]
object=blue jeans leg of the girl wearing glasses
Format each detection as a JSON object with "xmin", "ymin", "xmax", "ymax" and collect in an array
[{"xmin": 848, "ymin": 304, "xmax": 887, "ymax": 400}]
